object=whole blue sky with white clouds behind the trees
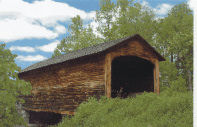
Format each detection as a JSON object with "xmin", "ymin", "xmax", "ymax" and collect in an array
[{"xmin": 0, "ymin": 0, "xmax": 192, "ymax": 69}]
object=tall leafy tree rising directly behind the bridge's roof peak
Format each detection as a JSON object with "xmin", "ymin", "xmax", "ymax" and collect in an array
[{"xmin": 96, "ymin": 0, "xmax": 157, "ymax": 43}]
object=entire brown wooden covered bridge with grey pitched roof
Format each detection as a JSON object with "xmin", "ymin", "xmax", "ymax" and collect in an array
[{"xmin": 19, "ymin": 35, "xmax": 165, "ymax": 125}]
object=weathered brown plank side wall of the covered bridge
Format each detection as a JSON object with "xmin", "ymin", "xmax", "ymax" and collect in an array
[{"xmin": 20, "ymin": 56, "xmax": 105, "ymax": 114}]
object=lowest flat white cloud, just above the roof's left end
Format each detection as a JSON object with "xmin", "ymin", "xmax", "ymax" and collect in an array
[{"xmin": 16, "ymin": 55, "xmax": 47, "ymax": 62}]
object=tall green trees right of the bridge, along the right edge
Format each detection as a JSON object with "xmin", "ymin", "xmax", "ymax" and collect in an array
[{"xmin": 155, "ymin": 3, "xmax": 193, "ymax": 90}]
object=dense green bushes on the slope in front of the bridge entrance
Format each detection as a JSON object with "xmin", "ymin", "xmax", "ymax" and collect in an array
[{"xmin": 58, "ymin": 87, "xmax": 193, "ymax": 127}]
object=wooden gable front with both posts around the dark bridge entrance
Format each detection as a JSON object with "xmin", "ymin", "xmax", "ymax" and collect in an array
[{"xmin": 105, "ymin": 40, "xmax": 159, "ymax": 97}]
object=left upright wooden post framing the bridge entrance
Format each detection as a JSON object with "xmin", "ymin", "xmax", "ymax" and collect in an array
[{"xmin": 105, "ymin": 54, "xmax": 111, "ymax": 98}]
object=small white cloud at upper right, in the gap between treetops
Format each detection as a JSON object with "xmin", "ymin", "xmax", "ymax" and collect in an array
[{"xmin": 153, "ymin": 3, "xmax": 173, "ymax": 15}]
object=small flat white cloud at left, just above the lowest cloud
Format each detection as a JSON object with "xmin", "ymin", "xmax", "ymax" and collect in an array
[{"xmin": 9, "ymin": 46, "xmax": 35, "ymax": 52}]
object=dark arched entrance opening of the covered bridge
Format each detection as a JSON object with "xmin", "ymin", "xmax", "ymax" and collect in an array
[{"xmin": 111, "ymin": 56, "xmax": 154, "ymax": 98}]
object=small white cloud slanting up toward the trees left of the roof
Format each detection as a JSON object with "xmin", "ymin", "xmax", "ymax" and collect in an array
[{"xmin": 37, "ymin": 40, "xmax": 60, "ymax": 52}]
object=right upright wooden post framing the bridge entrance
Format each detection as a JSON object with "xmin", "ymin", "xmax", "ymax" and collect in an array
[{"xmin": 154, "ymin": 60, "xmax": 159, "ymax": 94}]
